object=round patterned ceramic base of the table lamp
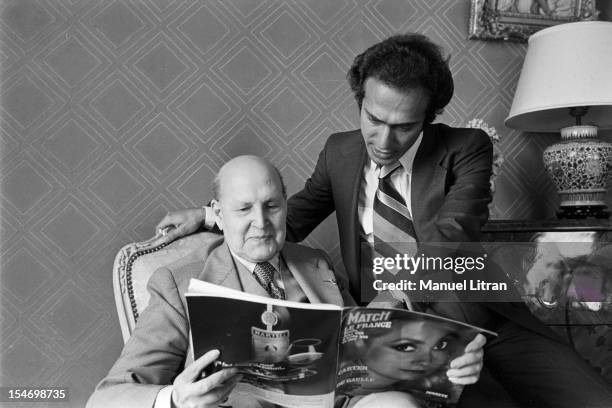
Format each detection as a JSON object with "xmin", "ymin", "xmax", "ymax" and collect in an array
[{"xmin": 544, "ymin": 126, "xmax": 612, "ymax": 218}]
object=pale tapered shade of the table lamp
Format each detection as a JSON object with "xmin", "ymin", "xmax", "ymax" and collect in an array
[{"xmin": 505, "ymin": 21, "xmax": 612, "ymax": 132}]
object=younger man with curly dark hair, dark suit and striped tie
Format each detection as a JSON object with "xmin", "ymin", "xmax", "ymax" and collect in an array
[{"xmin": 158, "ymin": 34, "xmax": 612, "ymax": 408}]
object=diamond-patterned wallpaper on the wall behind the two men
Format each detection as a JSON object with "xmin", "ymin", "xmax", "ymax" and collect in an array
[{"xmin": 0, "ymin": 0, "xmax": 608, "ymax": 407}]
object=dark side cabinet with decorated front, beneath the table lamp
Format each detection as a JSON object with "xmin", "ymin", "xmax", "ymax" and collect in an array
[{"xmin": 482, "ymin": 219, "xmax": 612, "ymax": 382}]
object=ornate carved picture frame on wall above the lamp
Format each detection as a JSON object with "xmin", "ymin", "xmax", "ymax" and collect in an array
[{"xmin": 468, "ymin": 0, "xmax": 599, "ymax": 42}]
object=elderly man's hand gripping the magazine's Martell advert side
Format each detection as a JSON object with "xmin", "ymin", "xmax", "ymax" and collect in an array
[{"xmin": 172, "ymin": 350, "xmax": 242, "ymax": 408}]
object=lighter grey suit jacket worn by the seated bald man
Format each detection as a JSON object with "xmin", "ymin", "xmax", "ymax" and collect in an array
[{"xmin": 88, "ymin": 239, "xmax": 354, "ymax": 408}]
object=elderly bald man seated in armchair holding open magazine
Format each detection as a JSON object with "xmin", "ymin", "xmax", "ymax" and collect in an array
[{"xmin": 88, "ymin": 156, "xmax": 484, "ymax": 408}]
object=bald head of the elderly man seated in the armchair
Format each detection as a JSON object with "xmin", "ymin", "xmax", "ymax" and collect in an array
[{"xmin": 212, "ymin": 156, "xmax": 287, "ymax": 263}]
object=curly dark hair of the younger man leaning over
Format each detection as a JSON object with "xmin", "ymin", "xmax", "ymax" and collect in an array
[{"xmin": 347, "ymin": 33, "xmax": 454, "ymax": 123}]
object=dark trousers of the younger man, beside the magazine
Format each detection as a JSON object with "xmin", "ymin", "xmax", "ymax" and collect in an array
[{"xmin": 458, "ymin": 319, "xmax": 612, "ymax": 408}]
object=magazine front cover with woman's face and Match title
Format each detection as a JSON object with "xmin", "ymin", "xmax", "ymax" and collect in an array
[{"xmin": 336, "ymin": 313, "xmax": 478, "ymax": 408}]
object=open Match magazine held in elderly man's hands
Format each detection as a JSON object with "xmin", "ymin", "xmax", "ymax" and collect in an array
[{"xmin": 186, "ymin": 279, "xmax": 496, "ymax": 408}]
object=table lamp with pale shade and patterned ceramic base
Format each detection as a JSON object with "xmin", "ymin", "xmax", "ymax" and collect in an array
[{"xmin": 505, "ymin": 21, "xmax": 612, "ymax": 218}]
